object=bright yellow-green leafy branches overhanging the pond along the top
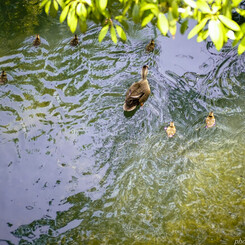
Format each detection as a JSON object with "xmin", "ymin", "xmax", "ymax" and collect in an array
[{"xmin": 40, "ymin": 0, "xmax": 245, "ymax": 54}]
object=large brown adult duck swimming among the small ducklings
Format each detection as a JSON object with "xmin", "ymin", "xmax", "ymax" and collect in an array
[{"xmin": 123, "ymin": 65, "xmax": 151, "ymax": 111}]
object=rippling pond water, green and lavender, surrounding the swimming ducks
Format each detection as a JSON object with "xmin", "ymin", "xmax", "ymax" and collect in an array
[{"xmin": 0, "ymin": 4, "xmax": 245, "ymax": 244}]
